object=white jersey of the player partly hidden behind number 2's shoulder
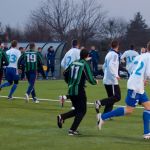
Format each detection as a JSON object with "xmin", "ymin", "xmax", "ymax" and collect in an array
[{"xmin": 121, "ymin": 50, "xmax": 139, "ymax": 74}]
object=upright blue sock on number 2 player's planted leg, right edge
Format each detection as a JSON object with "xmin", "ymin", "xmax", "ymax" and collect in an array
[{"xmin": 143, "ymin": 110, "xmax": 150, "ymax": 134}]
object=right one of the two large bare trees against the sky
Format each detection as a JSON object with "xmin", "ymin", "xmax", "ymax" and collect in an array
[{"xmin": 73, "ymin": 0, "xmax": 105, "ymax": 44}]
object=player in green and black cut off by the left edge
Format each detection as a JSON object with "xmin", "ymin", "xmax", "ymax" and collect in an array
[{"xmin": 0, "ymin": 41, "xmax": 9, "ymax": 84}]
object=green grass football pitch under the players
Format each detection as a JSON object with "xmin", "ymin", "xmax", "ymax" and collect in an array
[{"xmin": 0, "ymin": 80, "xmax": 150, "ymax": 150}]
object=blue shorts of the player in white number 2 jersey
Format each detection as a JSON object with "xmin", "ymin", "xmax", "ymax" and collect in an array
[{"xmin": 125, "ymin": 89, "xmax": 149, "ymax": 107}]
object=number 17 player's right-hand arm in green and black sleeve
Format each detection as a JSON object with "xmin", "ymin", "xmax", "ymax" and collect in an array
[{"xmin": 84, "ymin": 63, "xmax": 97, "ymax": 85}]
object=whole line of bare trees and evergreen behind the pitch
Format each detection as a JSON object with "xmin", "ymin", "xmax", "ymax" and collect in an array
[{"xmin": 0, "ymin": 0, "xmax": 150, "ymax": 50}]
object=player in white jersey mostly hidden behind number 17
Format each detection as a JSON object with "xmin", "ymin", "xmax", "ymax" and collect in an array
[{"xmin": 59, "ymin": 40, "xmax": 80, "ymax": 106}]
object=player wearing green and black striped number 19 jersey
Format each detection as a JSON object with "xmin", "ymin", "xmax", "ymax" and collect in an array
[{"xmin": 18, "ymin": 43, "xmax": 43, "ymax": 103}]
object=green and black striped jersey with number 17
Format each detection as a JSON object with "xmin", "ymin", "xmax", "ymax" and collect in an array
[{"xmin": 66, "ymin": 59, "xmax": 96, "ymax": 96}]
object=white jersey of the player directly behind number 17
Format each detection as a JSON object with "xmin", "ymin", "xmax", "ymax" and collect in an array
[{"xmin": 61, "ymin": 48, "xmax": 80, "ymax": 69}]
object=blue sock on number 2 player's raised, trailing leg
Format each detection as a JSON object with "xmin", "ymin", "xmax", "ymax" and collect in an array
[{"xmin": 101, "ymin": 107, "xmax": 125, "ymax": 120}]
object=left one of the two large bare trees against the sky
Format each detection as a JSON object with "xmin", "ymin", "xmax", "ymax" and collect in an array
[{"xmin": 32, "ymin": 0, "xmax": 74, "ymax": 40}]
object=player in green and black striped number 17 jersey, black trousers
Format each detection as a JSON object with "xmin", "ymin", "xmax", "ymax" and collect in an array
[{"xmin": 57, "ymin": 49, "xmax": 98, "ymax": 135}]
